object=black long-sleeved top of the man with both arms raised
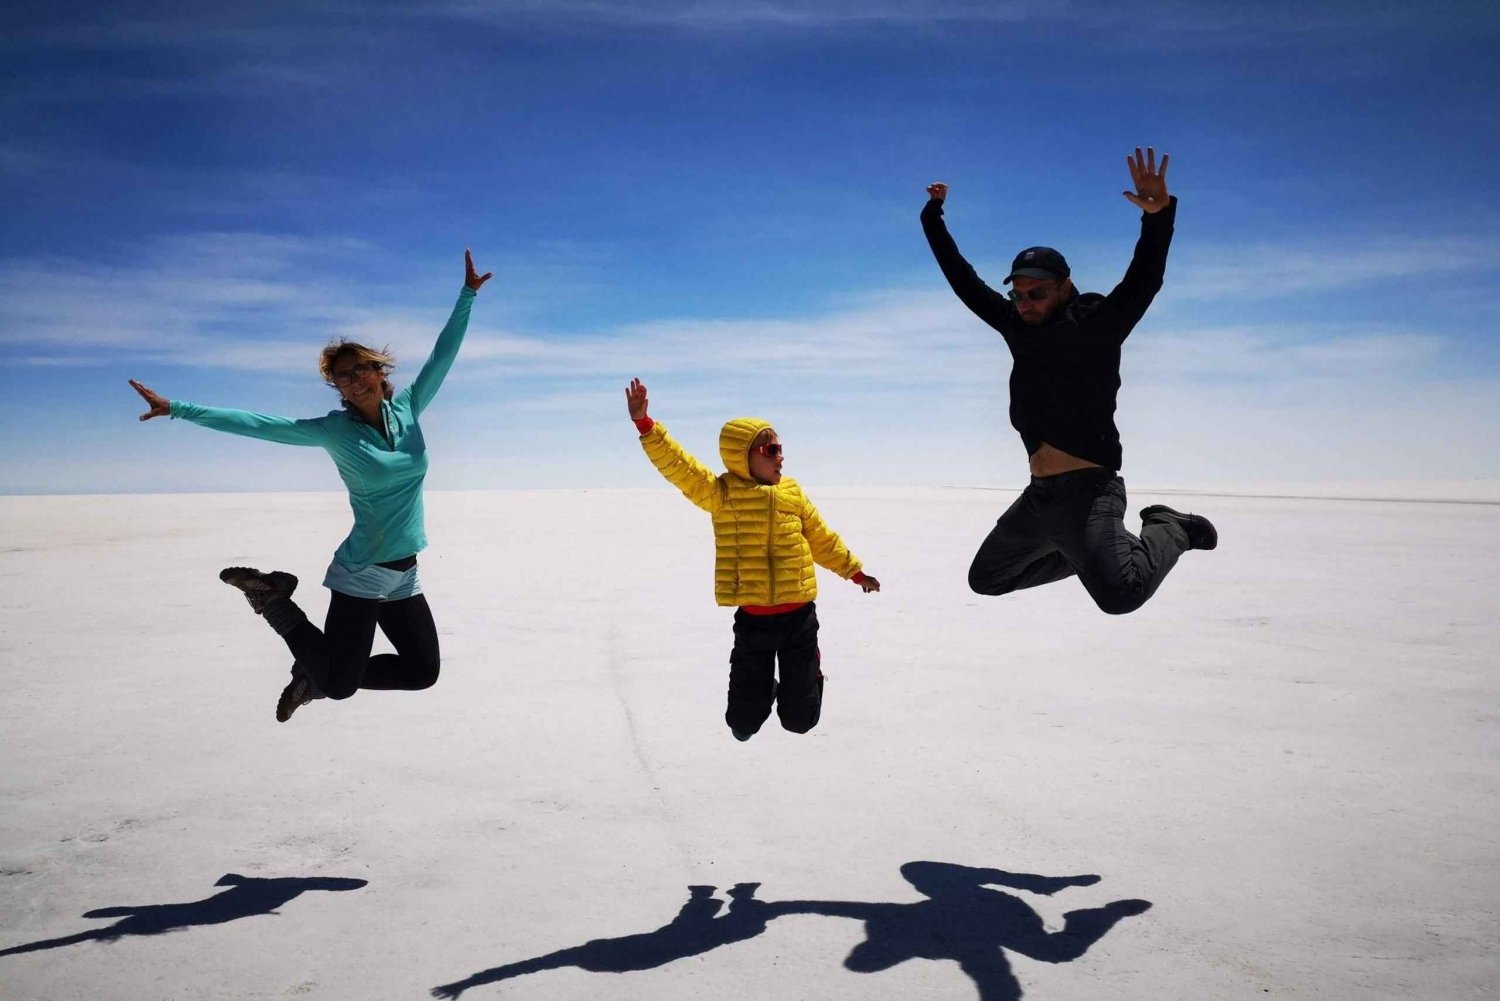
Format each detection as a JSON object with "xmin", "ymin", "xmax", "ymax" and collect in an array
[{"xmin": 923, "ymin": 197, "xmax": 1178, "ymax": 470}]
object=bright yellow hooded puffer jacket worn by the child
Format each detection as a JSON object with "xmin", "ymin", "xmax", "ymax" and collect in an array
[{"xmin": 641, "ymin": 417, "xmax": 860, "ymax": 605}]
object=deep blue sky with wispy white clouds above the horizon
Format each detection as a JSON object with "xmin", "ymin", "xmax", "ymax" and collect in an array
[{"xmin": 0, "ymin": 0, "xmax": 1500, "ymax": 492}]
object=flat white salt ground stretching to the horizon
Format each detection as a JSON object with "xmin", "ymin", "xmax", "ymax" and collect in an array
[{"xmin": 0, "ymin": 482, "xmax": 1500, "ymax": 1001}]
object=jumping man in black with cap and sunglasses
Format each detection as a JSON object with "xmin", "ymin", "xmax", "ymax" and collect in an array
[{"xmin": 923, "ymin": 147, "xmax": 1218, "ymax": 615}]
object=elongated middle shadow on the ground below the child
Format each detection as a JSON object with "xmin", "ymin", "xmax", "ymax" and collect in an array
[{"xmin": 432, "ymin": 882, "xmax": 773, "ymax": 998}]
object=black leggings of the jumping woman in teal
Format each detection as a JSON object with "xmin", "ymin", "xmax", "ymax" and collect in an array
[{"xmin": 284, "ymin": 591, "xmax": 438, "ymax": 699}]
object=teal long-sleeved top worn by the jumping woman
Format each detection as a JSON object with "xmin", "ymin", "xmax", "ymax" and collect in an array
[{"xmin": 171, "ymin": 285, "xmax": 474, "ymax": 567}]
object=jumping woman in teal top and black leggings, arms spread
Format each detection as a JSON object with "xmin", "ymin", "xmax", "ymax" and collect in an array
[{"xmin": 131, "ymin": 251, "xmax": 491, "ymax": 722}]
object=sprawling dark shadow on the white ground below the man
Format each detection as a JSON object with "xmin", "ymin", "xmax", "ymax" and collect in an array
[{"xmin": 776, "ymin": 861, "xmax": 1151, "ymax": 1001}]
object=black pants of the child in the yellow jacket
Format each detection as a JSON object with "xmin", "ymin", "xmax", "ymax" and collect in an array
[{"xmin": 725, "ymin": 602, "xmax": 824, "ymax": 734}]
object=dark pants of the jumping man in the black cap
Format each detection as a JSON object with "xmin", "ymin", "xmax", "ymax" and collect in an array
[{"xmin": 969, "ymin": 468, "xmax": 1188, "ymax": 615}]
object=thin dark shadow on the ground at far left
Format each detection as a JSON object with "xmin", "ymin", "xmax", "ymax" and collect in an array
[{"xmin": 0, "ymin": 872, "xmax": 368, "ymax": 956}]
